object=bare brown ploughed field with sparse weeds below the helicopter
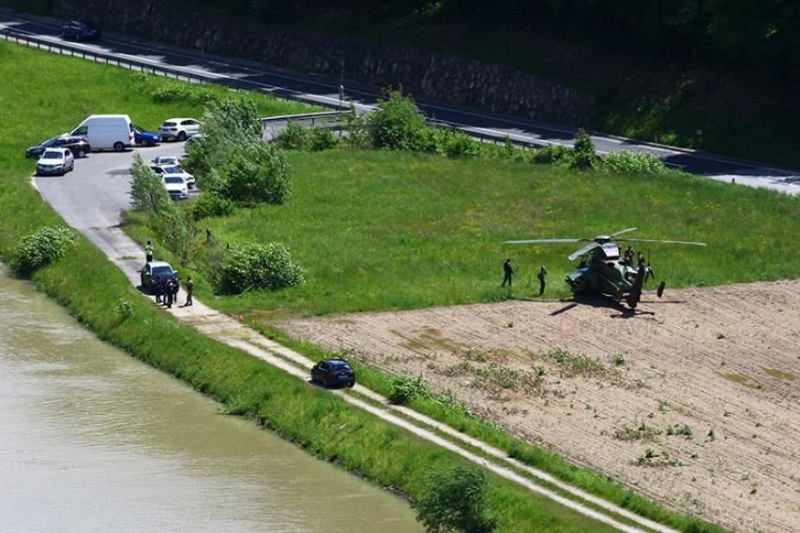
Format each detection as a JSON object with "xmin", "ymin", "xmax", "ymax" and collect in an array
[{"xmin": 280, "ymin": 282, "xmax": 800, "ymax": 532}]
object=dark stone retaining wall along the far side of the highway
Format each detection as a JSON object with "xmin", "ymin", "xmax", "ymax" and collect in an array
[{"xmin": 54, "ymin": 0, "xmax": 593, "ymax": 127}]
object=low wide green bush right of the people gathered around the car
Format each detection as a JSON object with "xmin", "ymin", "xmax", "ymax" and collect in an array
[{"xmin": 214, "ymin": 243, "xmax": 304, "ymax": 294}]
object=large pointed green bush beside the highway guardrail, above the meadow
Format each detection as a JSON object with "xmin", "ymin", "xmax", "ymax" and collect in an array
[{"xmin": 366, "ymin": 89, "xmax": 428, "ymax": 150}]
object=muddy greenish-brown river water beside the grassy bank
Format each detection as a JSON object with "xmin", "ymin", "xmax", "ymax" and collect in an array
[{"xmin": 0, "ymin": 270, "xmax": 421, "ymax": 533}]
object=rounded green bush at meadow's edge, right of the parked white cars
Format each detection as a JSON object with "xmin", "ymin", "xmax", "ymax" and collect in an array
[{"xmin": 220, "ymin": 142, "xmax": 292, "ymax": 204}]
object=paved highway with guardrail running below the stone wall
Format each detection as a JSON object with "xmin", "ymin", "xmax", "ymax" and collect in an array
[{"xmin": 0, "ymin": 10, "xmax": 800, "ymax": 194}]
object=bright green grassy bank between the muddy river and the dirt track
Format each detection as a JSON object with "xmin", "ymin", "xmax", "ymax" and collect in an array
[{"xmin": 0, "ymin": 43, "xmax": 644, "ymax": 532}]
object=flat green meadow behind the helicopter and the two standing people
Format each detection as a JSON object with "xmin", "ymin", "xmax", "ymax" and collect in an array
[{"xmin": 138, "ymin": 150, "xmax": 800, "ymax": 318}]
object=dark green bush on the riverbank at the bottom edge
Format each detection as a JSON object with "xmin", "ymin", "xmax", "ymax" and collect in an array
[{"xmin": 412, "ymin": 466, "xmax": 497, "ymax": 533}]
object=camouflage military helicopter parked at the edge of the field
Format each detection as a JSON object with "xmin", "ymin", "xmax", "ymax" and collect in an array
[{"xmin": 504, "ymin": 228, "xmax": 706, "ymax": 309}]
